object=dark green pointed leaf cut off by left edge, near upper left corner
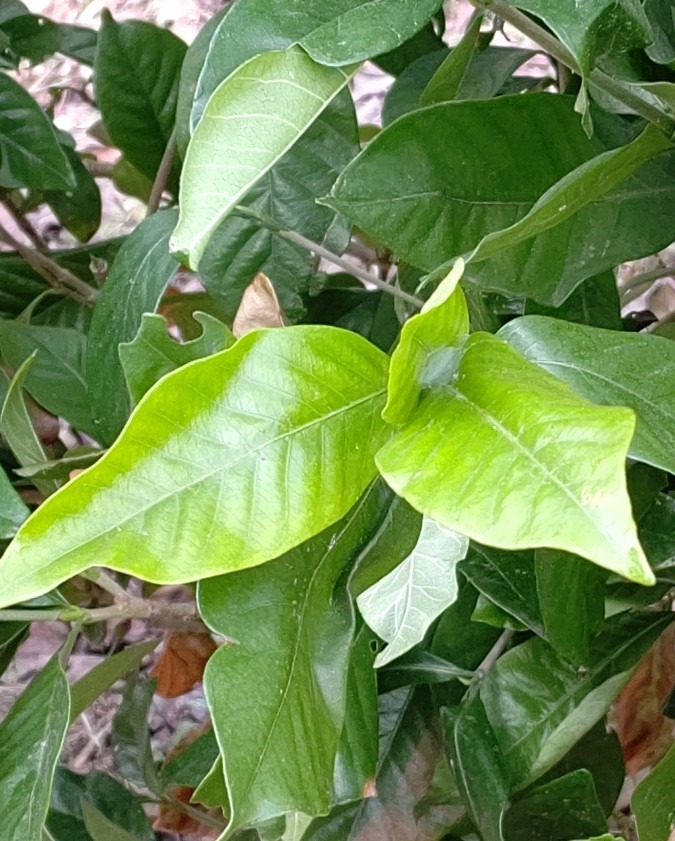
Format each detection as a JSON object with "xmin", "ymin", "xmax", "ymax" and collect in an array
[{"xmin": 0, "ymin": 73, "xmax": 76, "ymax": 190}]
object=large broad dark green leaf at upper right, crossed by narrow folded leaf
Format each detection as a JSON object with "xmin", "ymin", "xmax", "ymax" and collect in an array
[{"xmin": 326, "ymin": 94, "xmax": 675, "ymax": 306}]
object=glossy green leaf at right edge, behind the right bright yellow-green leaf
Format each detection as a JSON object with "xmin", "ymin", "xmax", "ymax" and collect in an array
[{"xmin": 499, "ymin": 316, "xmax": 675, "ymax": 473}]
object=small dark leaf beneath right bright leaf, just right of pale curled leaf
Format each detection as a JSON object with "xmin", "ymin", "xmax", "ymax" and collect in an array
[{"xmin": 459, "ymin": 543, "xmax": 544, "ymax": 636}]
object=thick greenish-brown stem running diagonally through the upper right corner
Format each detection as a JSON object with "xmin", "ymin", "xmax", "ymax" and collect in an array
[{"xmin": 470, "ymin": 0, "xmax": 675, "ymax": 137}]
